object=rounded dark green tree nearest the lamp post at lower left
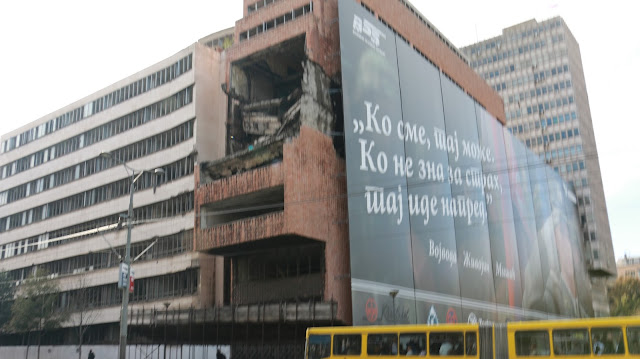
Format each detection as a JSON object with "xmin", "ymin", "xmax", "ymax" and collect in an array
[{"xmin": 9, "ymin": 271, "xmax": 63, "ymax": 333}]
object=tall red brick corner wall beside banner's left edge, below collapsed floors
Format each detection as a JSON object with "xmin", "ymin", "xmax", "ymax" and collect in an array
[{"xmin": 284, "ymin": 126, "xmax": 351, "ymax": 323}]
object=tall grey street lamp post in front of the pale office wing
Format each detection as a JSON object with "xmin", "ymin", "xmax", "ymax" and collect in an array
[{"xmin": 100, "ymin": 152, "xmax": 164, "ymax": 359}]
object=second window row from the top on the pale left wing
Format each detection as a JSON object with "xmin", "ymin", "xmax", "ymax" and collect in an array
[{"xmin": 2, "ymin": 86, "xmax": 193, "ymax": 178}]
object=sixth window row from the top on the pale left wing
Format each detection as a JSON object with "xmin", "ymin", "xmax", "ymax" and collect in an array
[{"xmin": 0, "ymin": 230, "xmax": 193, "ymax": 281}]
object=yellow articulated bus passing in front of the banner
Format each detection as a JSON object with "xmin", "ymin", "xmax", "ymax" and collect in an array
[{"xmin": 305, "ymin": 317, "xmax": 640, "ymax": 359}]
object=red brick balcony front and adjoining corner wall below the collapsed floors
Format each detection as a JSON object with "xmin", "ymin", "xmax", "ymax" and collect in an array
[{"xmin": 194, "ymin": 126, "xmax": 351, "ymax": 323}]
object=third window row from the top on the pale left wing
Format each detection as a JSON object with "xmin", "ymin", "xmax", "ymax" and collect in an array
[{"xmin": 0, "ymin": 111, "xmax": 193, "ymax": 210}]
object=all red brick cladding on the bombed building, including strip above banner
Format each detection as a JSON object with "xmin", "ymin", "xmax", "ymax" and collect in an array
[{"xmin": 194, "ymin": 0, "xmax": 505, "ymax": 323}]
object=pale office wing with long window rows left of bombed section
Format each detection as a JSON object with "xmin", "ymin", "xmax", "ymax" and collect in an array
[{"xmin": 0, "ymin": 30, "xmax": 231, "ymax": 341}]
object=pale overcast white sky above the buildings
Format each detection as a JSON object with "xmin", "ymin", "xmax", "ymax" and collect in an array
[{"xmin": 0, "ymin": 0, "xmax": 640, "ymax": 258}]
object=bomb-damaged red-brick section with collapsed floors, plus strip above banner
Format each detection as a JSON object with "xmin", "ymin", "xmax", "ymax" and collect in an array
[{"xmin": 194, "ymin": 0, "xmax": 504, "ymax": 354}]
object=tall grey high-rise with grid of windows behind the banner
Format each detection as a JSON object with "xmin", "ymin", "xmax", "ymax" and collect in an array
[{"xmin": 462, "ymin": 17, "xmax": 616, "ymax": 315}]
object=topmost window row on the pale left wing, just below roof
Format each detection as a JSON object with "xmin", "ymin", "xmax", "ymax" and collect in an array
[{"xmin": 0, "ymin": 54, "xmax": 192, "ymax": 153}]
